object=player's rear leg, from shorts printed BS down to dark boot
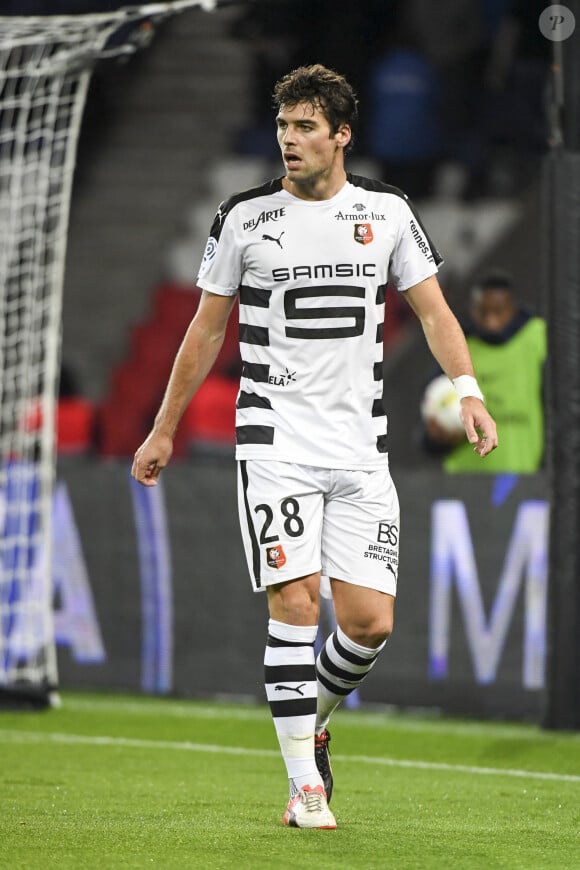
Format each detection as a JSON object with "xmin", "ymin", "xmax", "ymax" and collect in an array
[{"xmin": 316, "ymin": 469, "xmax": 399, "ymax": 794}]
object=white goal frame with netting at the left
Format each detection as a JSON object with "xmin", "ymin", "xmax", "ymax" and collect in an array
[{"xmin": 0, "ymin": 0, "xmax": 221, "ymax": 707}]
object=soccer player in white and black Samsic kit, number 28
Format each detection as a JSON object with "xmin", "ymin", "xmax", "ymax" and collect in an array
[{"xmin": 132, "ymin": 65, "xmax": 497, "ymax": 828}]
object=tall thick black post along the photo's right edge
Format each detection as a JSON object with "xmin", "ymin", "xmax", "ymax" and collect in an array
[{"xmin": 542, "ymin": 0, "xmax": 580, "ymax": 731}]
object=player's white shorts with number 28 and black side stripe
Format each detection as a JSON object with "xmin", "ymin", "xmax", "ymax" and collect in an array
[{"xmin": 238, "ymin": 459, "xmax": 399, "ymax": 595}]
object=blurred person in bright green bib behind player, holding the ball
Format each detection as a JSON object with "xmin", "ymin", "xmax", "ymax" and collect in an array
[{"xmin": 423, "ymin": 270, "xmax": 546, "ymax": 474}]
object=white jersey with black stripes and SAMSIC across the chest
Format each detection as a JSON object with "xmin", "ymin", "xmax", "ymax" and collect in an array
[{"xmin": 197, "ymin": 174, "xmax": 441, "ymax": 469}]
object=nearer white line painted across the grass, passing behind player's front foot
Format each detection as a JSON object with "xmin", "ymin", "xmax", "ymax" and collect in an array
[{"xmin": 0, "ymin": 730, "xmax": 580, "ymax": 783}]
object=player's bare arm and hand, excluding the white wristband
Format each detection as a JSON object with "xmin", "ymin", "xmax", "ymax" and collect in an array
[{"xmin": 405, "ymin": 275, "xmax": 498, "ymax": 456}]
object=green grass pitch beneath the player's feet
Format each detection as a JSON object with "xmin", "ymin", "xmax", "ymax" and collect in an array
[{"xmin": 0, "ymin": 694, "xmax": 580, "ymax": 870}]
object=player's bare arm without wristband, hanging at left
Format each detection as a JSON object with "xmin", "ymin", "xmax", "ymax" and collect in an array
[{"xmin": 131, "ymin": 292, "xmax": 236, "ymax": 486}]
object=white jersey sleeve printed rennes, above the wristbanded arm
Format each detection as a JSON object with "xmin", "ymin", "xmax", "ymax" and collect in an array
[{"xmin": 390, "ymin": 196, "xmax": 443, "ymax": 291}]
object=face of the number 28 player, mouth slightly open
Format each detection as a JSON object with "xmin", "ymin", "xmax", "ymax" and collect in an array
[{"xmin": 276, "ymin": 103, "xmax": 351, "ymax": 184}]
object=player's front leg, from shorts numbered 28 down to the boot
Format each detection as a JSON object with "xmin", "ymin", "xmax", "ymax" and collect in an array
[{"xmin": 238, "ymin": 461, "xmax": 336, "ymax": 827}]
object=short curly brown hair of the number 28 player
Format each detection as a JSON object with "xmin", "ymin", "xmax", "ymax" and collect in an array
[{"xmin": 272, "ymin": 63, "xmax": 358, "ymax": 150}]
